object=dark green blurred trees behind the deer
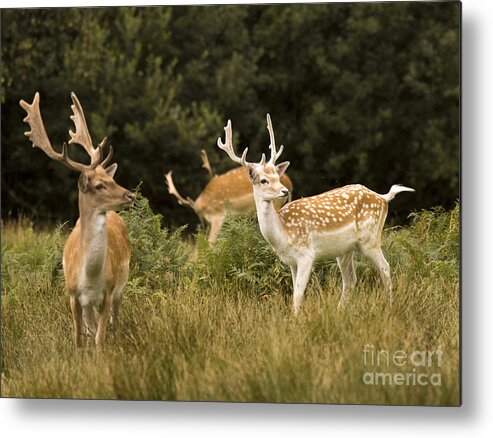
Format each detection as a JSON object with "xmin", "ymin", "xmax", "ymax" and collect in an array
[{"xmin": 1, "ymin": 2, "xmax": 460, "ymax": 228}]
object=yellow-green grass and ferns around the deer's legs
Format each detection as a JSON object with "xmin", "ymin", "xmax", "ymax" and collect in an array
[{"xmin": 1, "ymin": 197, "xmax": 460, "ymax": 405}]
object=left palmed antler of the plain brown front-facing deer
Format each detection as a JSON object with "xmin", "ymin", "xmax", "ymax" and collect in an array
[{"xmin": 19, "ymin": 92, "xmax": 85, "ymax": 172}]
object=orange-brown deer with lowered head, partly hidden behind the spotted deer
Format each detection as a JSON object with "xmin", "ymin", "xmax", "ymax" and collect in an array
[{"xmin": 165, "ymin": 150, "xmax": 293, "ymax": 243}]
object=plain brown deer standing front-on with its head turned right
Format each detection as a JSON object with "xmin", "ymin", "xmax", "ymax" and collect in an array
[{"xmin": 20, "ymin": 93, "xmax": 135, "ymax": 347}]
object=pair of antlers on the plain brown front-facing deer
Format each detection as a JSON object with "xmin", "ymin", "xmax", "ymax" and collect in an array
[{"xmin": 19, "ymin": 92, "xmax": 113, "ymax": 172}]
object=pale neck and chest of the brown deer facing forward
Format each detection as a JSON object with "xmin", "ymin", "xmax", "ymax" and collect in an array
[{"xmin": 79, "ymin": 197, "xmax": 108, "ymax": 277}]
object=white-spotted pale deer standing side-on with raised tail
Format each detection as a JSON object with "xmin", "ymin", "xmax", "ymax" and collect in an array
[{"xmin": 217, "ymin": 114, "xmax": 414, "ymax": 315}]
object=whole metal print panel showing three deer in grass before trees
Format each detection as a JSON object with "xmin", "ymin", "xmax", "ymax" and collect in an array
[{"xmin": 1, "ymin": 2, "xmax": 461, "ymax": 406}]
